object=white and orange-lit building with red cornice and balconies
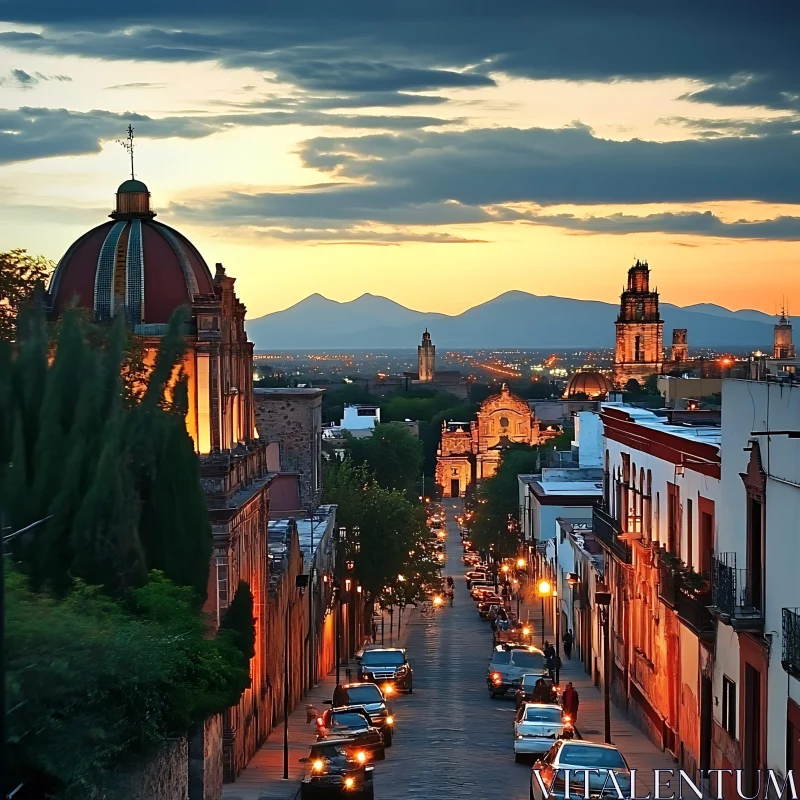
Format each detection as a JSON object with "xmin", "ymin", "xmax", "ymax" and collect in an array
[{"xmin": 592, "ymin": 404, "xmax": 722, "ymax": 775}]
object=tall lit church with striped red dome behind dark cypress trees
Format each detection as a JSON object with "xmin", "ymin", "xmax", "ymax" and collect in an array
[{"xmin": 49, "ymin": 175, "xmax": 273, "ymax": 780}]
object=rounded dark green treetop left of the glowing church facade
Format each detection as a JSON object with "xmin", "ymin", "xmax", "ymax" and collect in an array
[{"xmin": 348, "ymin": 423, "xmax": 422, "ymax": 496}]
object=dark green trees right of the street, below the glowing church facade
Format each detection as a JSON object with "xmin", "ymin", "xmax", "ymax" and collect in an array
[{"xmin": 471, "ymin": 444, "xmax": 538, "ymax": 557}]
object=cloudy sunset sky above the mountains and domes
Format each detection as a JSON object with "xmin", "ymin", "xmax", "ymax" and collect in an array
[{"xmin": 0, "ymin": 0, "xmax": 800, "ymax": 317}]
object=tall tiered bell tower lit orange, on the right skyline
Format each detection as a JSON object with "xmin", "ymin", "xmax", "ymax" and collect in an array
[{"xmin": 614, "ymin": 259, "xmax": 664, "ymax": 388}]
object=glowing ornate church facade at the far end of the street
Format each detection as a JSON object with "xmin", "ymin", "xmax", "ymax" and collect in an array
[{"xmin": 436, "ymin": 384, "xmax": 557, "ymax": 497}]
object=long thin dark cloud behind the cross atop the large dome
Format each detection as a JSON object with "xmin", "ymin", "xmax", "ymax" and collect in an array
[{"xmin": 0, "ymin": 107, "xmax": 460, "ymax": 164}]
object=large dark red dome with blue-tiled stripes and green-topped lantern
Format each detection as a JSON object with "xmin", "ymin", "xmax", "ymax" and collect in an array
[{"xmin": 50, "ymin": 180, "xmax": 214, "ymax": 332}]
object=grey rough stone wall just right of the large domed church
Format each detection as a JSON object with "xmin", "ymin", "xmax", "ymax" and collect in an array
[{"xmin": 254, "ymin": 389, "xmax": 322, "ymax": 507}]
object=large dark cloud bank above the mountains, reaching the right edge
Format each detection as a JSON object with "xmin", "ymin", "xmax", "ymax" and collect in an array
[{"xmin": 164, "ymin": 125, "xmax": 800, "ymax": 233}]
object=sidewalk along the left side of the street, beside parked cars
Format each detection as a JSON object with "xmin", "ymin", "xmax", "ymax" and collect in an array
[{"xmin": 222, "ymin": 607, "xmax": 418, "ymax": 800}]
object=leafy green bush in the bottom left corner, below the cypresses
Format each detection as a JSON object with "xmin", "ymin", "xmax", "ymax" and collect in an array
[{"xmin": 5, "ymin": 568, "xmax": 249, "ymax": 800}]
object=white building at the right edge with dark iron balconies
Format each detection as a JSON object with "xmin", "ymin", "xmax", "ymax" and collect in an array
[{"xmin": 714, "ymin": 380, "xmax": 800, "ymax": 796}]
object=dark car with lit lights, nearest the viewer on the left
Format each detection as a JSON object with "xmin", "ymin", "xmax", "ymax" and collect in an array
[{"xmin": 300, "ymin": 739, "xmax": 375, "ymax": 800}]
